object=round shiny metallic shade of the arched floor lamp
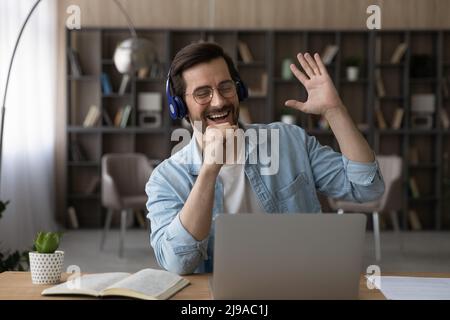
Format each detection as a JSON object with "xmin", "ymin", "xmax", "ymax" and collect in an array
[{"xmin": 113, "ymin": 38, "xmax": 155, "ymax": 73}]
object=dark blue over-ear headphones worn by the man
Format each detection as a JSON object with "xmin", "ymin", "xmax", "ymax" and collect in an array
[{"xmin": 166, "ymin": 69, "xmax": 248, "ymax": 120}]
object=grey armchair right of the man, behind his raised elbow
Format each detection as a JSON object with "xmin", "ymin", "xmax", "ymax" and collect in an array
[{"xmin": 328, "ymin": 155, "xmax": 402, "ymax": 261}]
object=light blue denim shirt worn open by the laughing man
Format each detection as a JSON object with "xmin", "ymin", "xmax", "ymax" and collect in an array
[{"xmin": 145, "ymin": 123, "xmax": 384, "ymax": 274}]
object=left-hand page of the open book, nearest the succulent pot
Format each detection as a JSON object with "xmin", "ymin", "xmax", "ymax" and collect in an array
[{"xmin": 42, "ymin": 272, "xmax": 130, "ymax": 295}]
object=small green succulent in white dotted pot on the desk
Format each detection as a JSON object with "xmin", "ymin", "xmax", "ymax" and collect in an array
[{"xmin": 29, "ymin": 232, "xmax": 64, "ymax": 284}]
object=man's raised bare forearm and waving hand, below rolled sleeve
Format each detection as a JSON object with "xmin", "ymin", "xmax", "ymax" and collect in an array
[{"xmin": 286, "ymin": 53, "xmax": 375, "ymax": 163}]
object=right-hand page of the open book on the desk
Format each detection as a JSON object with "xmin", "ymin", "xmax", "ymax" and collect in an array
[{"xmin": 104, "ymin": 269, "xmax": 189, "ymax": 299}]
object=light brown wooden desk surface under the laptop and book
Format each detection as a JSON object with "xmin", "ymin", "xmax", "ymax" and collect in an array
[{"xmin": 0, "ymin": 272, "xmax": 450, "ymax": 300}]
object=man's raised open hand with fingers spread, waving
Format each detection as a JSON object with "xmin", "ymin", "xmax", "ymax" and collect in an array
[{"xmin": 285, "ymin": 53, "xmax": 343, "ymax": 116}]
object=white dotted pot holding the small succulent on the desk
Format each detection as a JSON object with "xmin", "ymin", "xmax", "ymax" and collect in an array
[{"xmin": 29, "ymin": 250, "xmax": 64, "ymax": 284}]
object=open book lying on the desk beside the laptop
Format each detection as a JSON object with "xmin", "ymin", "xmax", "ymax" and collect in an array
[{"xmin": 41, "ymin": 269, "xmax": 189, "ymax": 300}]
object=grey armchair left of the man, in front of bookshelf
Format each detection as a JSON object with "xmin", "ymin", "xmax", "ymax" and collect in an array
[{"xmin": 100, "ymin": 153, "xmax": 153, "ymax": 257}]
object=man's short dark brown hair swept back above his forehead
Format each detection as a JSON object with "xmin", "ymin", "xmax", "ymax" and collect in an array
[{"xmin": 170, "ymin": 42, "xmax": 239, "ymax": 100}]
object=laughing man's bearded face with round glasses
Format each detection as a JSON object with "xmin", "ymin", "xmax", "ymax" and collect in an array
[{"xmin": 182, "ymin": 58, "xmax": 239, "ymax": 132}]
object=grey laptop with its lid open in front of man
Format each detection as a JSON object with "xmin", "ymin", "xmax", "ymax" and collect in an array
[{"xmin": 210, "ymin": 214, "xmax": 366, "ymax": 299}]
